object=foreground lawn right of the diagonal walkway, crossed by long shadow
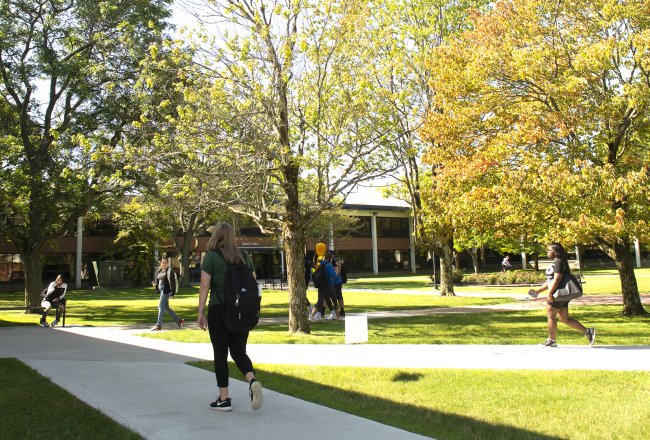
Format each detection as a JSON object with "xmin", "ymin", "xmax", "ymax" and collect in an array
[{"xmin": 192, "ymin": 362, "xmax": 650, "ymax": 440}]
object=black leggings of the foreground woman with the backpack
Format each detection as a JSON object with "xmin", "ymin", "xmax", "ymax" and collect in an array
[{"xmin": 208, "ymin": 306, "xmax": 255, "ymax": 388}]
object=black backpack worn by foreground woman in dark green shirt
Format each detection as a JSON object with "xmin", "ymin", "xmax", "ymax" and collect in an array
[{"xmin": 217, "ymin": 251, "xmax": 262, "ymax": 333}]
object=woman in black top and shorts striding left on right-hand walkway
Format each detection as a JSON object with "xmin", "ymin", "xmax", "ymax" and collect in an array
[{"xmin": 528, "ymin": 243, "xmax": 596, "ymax": 347}]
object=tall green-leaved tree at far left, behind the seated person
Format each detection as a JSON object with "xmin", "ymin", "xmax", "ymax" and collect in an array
[{"xmin": 0, "ymin": 0, "xmax": 169, "ymax": 306}]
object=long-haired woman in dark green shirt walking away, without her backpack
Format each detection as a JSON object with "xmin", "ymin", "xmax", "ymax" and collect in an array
[{"xmin": 198, "ymin": 223, "xmax": 264, "ymax": 411}]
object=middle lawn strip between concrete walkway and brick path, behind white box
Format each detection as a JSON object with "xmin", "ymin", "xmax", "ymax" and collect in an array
[{"xmin": 142, "ymin": 306, "xmax": 650, "ymax": 345}]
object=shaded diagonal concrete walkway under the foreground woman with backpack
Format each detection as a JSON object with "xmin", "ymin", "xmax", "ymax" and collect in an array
[{"xmin": 0, "ymin": 326, "xmax": 425, "ymax": 440}]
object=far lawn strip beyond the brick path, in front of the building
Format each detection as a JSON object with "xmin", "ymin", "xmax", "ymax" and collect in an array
[{"xmin": 0, "ymin": 268, "xmax": 650, "ymax": 326}]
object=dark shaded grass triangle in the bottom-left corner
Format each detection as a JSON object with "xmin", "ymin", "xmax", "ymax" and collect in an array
[{"xmin": 0, "ymin": 359, "xmax": 142, "ymax": 440}]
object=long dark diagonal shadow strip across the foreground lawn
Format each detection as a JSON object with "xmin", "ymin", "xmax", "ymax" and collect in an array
[{"xmin": 189, "ymin": 361, "xmax": 559, "ymax": 440}]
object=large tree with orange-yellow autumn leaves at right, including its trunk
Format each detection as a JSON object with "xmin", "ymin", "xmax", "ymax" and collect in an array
[{"xmin": 424, "ymin": 0, "xmax": 650, "ymax": 314}]
